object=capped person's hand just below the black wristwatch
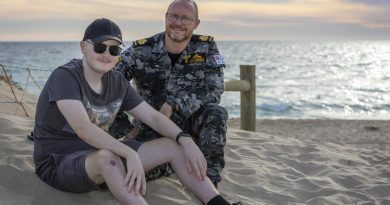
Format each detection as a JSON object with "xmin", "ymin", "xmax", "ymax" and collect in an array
[{"xmin": 179, "ymin": 137, "xmax": 207, "ymax": 180}]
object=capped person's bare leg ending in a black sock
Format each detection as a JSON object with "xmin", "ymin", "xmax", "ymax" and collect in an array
[{"xmin": 137, "ymin": 138, "xmax": 219, "ymax": 204}]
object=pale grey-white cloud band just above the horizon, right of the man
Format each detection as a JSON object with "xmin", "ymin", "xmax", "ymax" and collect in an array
[{"xmin": 197, "ymin": 19, "xmax": 390, "ymax": 41}]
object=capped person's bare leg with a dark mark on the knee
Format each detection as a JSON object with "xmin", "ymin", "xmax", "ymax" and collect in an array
[{"xmin": 85, "ymin": 150, "xmax": 148, "ymax": 205}]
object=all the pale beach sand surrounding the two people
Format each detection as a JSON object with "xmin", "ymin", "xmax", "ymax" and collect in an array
[{"xmin": 0, "ymin": 79, "xmax": 390, "ymax": 205}]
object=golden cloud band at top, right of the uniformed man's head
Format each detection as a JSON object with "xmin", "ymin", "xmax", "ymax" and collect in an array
[{"xmin": 201, "ymin": 0, "xmax": 390, "ymax": 27}]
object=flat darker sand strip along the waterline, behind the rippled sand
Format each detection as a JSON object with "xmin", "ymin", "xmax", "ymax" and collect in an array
[{"xmin": 228, "ymin": 116, "xmax": 390, "ymax": 152}]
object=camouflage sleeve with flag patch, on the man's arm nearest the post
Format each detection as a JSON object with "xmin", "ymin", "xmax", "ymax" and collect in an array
[{"xmin": 169, "ymin": 41, "xmax": 225, "ymax": 119}]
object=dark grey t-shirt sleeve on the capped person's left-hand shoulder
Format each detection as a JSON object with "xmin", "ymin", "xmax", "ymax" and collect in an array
[{"xmin": 48, "ymin": 68, "xmax": 81, "ymax": 102}]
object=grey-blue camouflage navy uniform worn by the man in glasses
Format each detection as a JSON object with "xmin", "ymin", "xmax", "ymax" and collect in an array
[{"xmin": 115, "ymin": 32, "xmax": 228, "ymax": 183}]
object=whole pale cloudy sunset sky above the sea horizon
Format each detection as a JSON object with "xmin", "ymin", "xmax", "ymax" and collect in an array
[{"xmin": 0, "ymin": 0, "xmax": 390, "ymax": 41}]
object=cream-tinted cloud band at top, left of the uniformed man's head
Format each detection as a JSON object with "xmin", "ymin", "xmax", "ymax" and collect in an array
[{"xmin": 0, "ymin": 0, "xmax": 166, "ymax": 21}]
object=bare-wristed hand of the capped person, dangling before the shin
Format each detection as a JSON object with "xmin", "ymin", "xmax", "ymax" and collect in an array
[{"xmin": 125, "ymin": 152, "xmax": 146, "ymax": 195}]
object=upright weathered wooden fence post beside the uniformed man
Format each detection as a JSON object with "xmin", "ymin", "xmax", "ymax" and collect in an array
[{"xmin": 240, "ymin": 65, "xmax": 256, "ymax": 131}]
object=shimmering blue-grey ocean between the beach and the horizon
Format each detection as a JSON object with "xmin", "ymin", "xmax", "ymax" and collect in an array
[{"xmin": 0, "ymin": 41, "xmax": 390, "ymax": 119}]
